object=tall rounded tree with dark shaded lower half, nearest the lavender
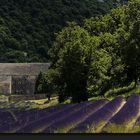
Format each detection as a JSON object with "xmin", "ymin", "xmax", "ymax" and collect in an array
[{"xmin": 49, "ymin": 23, "xmax": 89, "ymax": 102}]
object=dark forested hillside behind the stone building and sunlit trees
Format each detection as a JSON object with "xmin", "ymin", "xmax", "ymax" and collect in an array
[{"xmin": 0, "ymin": 0, "xmax": 123, "ymax": 62}]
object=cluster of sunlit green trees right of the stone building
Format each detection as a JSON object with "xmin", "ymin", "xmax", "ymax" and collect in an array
[{"xmin": 34, "ymin": 0, "xmax": 140, "ymax": 102}]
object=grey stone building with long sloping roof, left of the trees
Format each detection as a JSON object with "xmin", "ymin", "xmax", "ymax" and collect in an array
[{"xmin": 0, "ymin": 63, "xmax": 49, "ymax": 95}]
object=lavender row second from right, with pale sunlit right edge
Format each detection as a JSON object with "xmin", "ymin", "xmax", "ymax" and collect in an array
[{"xmin": 68, "ymin": 96, "xmax": 125, "ymax": 133}]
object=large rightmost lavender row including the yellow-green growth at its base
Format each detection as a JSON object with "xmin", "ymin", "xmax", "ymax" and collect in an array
[{"xmin": 104, "ymin": 94, "xmax": 140, "ymax": 133}]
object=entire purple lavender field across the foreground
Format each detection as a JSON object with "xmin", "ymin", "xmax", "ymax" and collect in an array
[{"xmin": 0, "ymin": 94, "xmax": 140, "ymax": 134}]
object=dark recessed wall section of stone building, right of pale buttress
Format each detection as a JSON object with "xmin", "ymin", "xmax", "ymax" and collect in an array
[{"xmin": 12, "ymin": 76, "xmax": 35, "ymax": 95}]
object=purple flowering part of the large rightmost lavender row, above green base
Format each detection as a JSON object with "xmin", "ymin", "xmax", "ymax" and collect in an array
[{"xmin": 104, "ymin": 94, "xmax": 140, "ymax": 129}]
